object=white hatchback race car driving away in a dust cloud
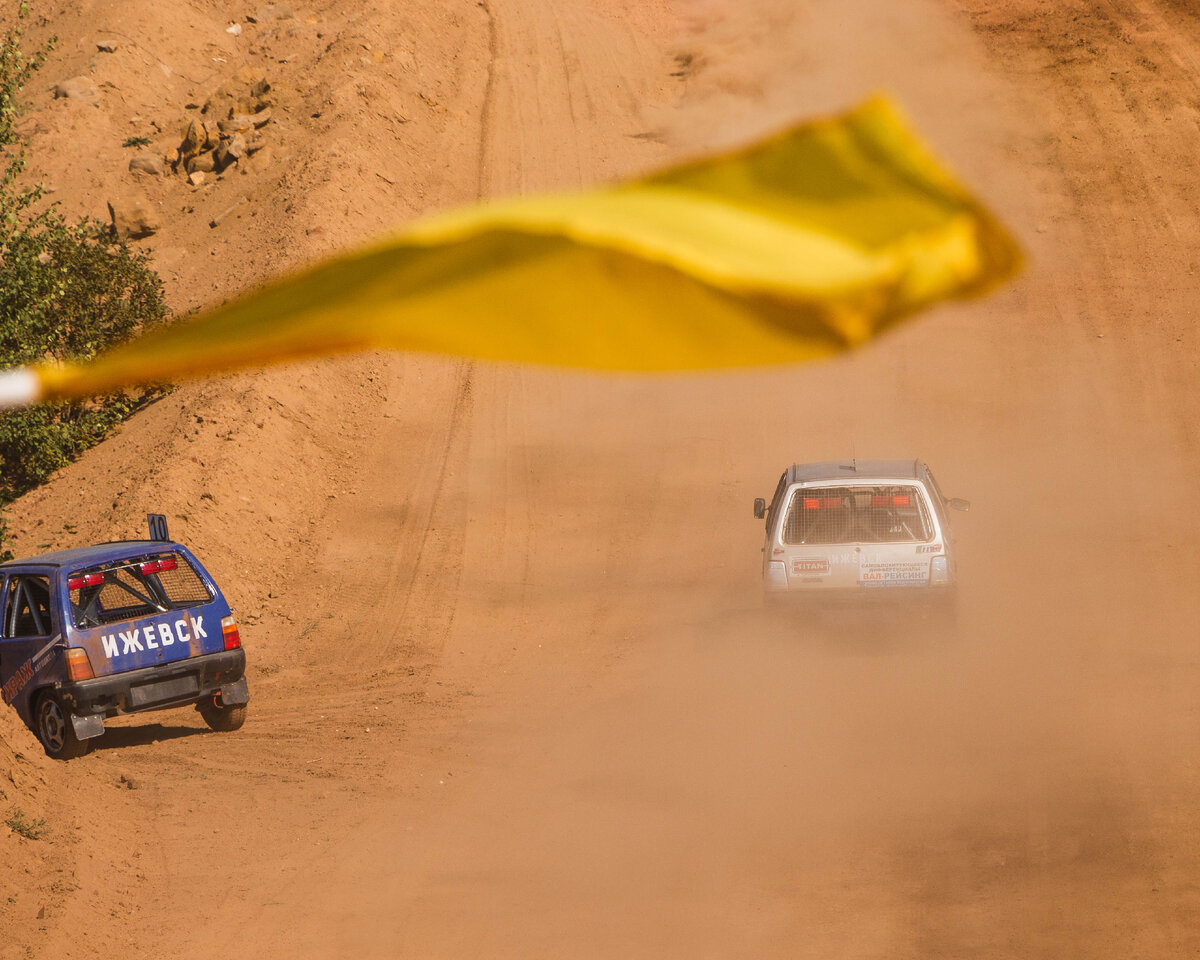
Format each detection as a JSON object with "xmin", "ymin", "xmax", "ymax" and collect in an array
[{"xmin": 754, "ymin": 460, "xmax": 971, "ymax": 601}]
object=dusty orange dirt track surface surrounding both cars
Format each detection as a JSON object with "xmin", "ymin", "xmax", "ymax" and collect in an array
[{"xmin": 0, "ymin": 0, "xmax": 1200, "ymax": 959}]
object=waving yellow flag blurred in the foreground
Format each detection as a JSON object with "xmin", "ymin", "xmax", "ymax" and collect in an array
[{"xmin": 7, "ymin": 98, "xmax": 1019, "ymax": 408}]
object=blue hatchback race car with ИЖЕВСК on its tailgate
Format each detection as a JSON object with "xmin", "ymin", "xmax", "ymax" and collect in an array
[{"xmin": 0, "ymin": 515, "xmax": 250, "ymax": 760}]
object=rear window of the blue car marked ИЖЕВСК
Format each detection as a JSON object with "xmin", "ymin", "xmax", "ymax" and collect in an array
[{"xmin": 68, "ymin": 552, "xmax": 212, "ymax": 629}]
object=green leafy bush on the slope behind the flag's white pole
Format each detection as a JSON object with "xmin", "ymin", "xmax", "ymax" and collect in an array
[{"xmin": 0, "ymin": 4, "xmax": 167, "ymax": 559}]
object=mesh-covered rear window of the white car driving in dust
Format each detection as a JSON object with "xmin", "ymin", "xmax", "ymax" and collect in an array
[{"xmin": 782, "ymin": 485, "xmax": 931, "ymax": 544}]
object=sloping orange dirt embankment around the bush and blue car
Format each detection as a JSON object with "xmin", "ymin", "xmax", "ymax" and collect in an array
[{"xmin": 0, "ymin": 2, "xmax": 484, "ymax": 955}]
